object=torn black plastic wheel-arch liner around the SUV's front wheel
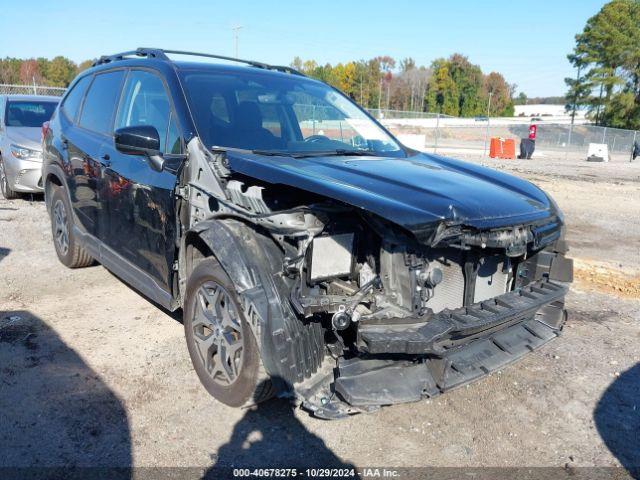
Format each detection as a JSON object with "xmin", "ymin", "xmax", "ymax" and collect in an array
[{"xmin": 179, "ymin": 218, "xmax": 324, "ymax": 391}]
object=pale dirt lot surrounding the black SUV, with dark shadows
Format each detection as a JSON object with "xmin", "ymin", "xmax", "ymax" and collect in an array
[{"xmin": 0, "ymin": 156, "xmax": 640, "ymax": 474}]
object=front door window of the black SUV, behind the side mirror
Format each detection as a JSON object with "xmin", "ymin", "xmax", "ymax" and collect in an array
[{"xmin": 115, "ymin": 70, "xmax": 180, "ymax": 153}]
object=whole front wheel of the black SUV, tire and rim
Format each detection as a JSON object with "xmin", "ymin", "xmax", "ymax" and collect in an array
[{"xmin": 183, "ymin": 257, "xmax": 274, "ymax": 407}]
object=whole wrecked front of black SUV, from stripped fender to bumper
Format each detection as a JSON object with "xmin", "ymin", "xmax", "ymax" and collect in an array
[{"xmin": 183, "ymin": 145, "xmax": 573, "ymax": 418}]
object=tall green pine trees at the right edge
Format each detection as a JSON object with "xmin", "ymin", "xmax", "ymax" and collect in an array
[{"xmin": 565, "ymin": 0, "xmax": 640, "ymax": 130}]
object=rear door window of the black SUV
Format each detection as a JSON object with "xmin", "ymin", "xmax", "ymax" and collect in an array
[{"xmin": 79, "ymin": 70, "xmax": 124, "ymax": 134}]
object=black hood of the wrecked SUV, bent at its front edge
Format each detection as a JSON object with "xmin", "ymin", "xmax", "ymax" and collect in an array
[{"xmin": 228, "ymin": 152, "xmax": 552, "ymax": 232}]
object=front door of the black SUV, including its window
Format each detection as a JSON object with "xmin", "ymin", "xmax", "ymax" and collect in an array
[{"xmin": 103, "ymin": 69, "xmax": 182, "ymax": 292}]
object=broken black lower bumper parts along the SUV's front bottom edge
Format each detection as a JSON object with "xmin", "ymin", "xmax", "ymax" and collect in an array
[{"xmin": 296, "ymin": 279, "xmax": 568, "ymax": 418}]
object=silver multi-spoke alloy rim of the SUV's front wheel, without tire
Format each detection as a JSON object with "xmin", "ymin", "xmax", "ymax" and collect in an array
[{"xmin": 191, "ymin": 281, "xmax": 244, "ymax": 386}]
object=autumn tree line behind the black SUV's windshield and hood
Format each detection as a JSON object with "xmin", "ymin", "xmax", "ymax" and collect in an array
[{"xmin": 291, "ymin": 53, "xmax": 516, "ymax": 117}]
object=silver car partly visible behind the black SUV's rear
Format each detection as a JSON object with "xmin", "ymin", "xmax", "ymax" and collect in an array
[{"xmin": 0, "ymin": 95, "xmax": 60, "ymax": 199}]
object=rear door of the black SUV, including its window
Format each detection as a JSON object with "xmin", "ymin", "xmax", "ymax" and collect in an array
[{"xmin": 67, "ymin": 69, "xmax": 125, "ymax": 240}]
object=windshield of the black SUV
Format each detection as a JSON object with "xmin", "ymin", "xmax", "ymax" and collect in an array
[{"xmin": 181, "ymin": 70, "xmax": 404, "ymax": 157}]
